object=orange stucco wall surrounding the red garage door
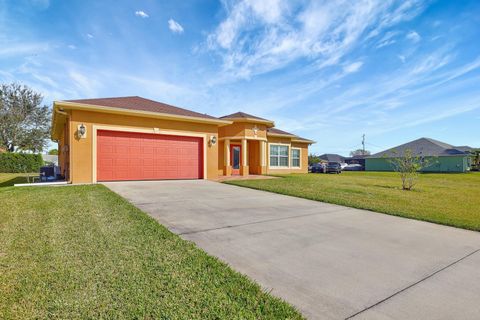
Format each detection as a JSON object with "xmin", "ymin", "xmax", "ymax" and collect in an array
[{"xmin": 70, "ymin": 110, "xmax": 218, "ymax": 183}]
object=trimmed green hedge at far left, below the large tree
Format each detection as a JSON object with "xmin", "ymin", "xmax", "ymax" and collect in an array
[{"xmin": 0, "ymin": 152, "xmax": 43, "ymax": 173}]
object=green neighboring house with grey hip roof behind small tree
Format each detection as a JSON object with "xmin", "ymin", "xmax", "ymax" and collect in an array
[{"xmin": 365, "ymin": 138, "xmax": 472, "ymax": 172}]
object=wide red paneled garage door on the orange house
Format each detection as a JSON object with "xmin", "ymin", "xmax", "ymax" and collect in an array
[{"xmin": 97, "ymin": 130, "xmax": 203, "ymax": 181}]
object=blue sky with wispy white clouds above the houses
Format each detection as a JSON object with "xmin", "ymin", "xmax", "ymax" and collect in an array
[{"xmin": 0, "ymin": 0, "xmax": 480, "ymax": 155}]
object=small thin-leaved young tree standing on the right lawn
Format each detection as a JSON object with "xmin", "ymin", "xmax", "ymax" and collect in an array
[{"xmin": 389, "ymin": 149, "xmax": 430, "ymax": 191}]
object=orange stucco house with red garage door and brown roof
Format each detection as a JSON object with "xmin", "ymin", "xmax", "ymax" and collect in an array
[{"xmin": 51, "ymin": 97, "xmax": 314, "ymax": 183}]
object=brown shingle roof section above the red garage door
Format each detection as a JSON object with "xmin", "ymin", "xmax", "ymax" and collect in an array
[{"xmin": 64, "ymin": 96, "xmax": 218, "ymax": 119}]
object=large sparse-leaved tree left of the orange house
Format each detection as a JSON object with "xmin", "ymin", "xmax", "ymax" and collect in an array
[{"xmin": 0, "ymin": 83, "xmax": 51, "ymax": 152}]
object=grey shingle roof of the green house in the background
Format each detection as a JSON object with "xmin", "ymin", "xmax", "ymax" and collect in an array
[{"xmin": 368, "ymin": 138, "xmax": 467, "ymax": 158}]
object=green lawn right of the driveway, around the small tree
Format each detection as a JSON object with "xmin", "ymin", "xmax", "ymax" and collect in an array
[{"xmin": 226, "ymin": 172, "xmax": 480, "ymax": 231}]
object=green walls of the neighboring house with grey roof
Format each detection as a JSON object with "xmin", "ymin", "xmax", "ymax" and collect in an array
[{"xmin": 365, "ymin": 156, "xmax": 468, "ymax": 172}]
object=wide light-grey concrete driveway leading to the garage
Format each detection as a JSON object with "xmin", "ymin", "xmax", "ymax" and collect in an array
[{"xmin": 106, "ymin": 181, "xmax": 480, "ymax": 319}]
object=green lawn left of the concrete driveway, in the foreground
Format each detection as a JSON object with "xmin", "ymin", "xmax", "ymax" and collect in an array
[{"xmin": 0, "ymin": 174, "xmax": 302, "ymax": 319}]
